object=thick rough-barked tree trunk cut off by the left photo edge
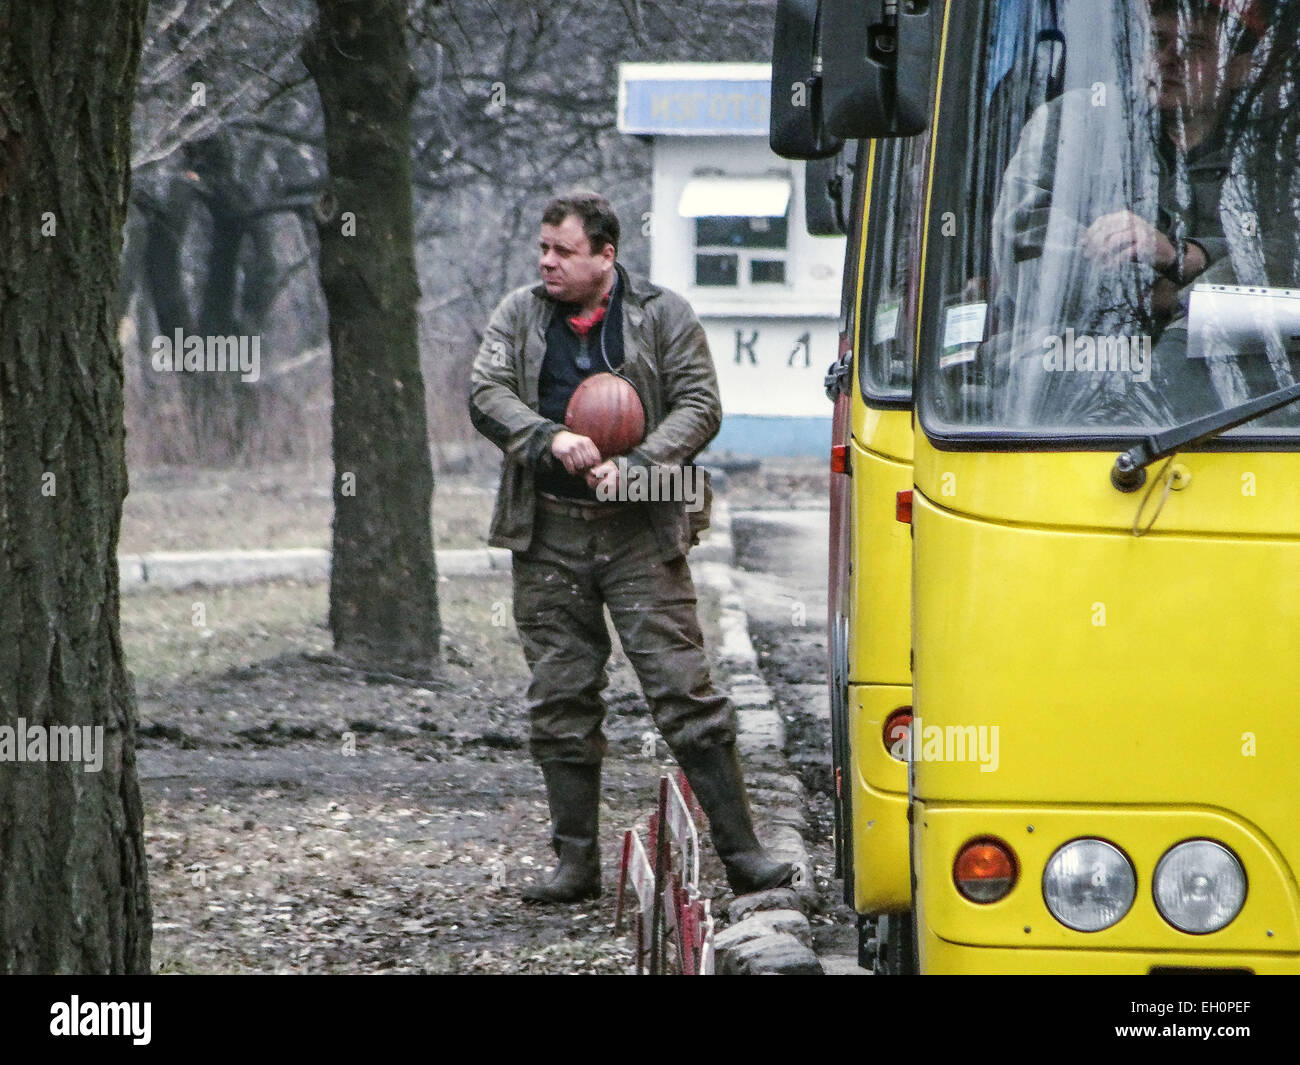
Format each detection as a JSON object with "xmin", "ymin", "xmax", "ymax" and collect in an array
[{"xmin": 0, "ymin": 0, "xmax": 152, "ymax": 973}]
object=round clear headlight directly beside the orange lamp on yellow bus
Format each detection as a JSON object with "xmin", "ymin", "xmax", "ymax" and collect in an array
[{"xmin": 1043, "ymin": 840, "xmax": 1138, "ymax": 932}]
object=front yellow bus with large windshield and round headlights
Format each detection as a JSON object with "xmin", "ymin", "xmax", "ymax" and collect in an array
[{"xmin": 780, "ymin": 0, "xmax": 1300, "ymax": 973}]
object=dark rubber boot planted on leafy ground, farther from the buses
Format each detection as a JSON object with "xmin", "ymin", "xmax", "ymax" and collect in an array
[{"xmin": 523, "ymin": 762, "xmax": 601, "ymax": 902}]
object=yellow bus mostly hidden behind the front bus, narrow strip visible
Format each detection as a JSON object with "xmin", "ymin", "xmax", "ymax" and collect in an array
[{"xmin": 774, "ymin": 4, "xmax": 930, "ymax": 971}]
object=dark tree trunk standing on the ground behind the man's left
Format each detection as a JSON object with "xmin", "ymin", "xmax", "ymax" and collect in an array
[{"xmin": 303, "ymin": 0, "xmax": 441, "ymax": 666}]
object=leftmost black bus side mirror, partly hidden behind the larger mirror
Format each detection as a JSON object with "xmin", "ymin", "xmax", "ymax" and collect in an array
[{"xmin": 768, "ymin": 0, "xmax": 844, "ymax": 159}]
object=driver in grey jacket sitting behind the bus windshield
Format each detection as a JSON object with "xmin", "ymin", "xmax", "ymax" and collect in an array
[{"xmin": 995, "ymin": 0, "xmax": 1292, "ymax": 424}]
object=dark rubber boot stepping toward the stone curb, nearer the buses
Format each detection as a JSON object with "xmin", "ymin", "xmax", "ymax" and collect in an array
[{"xmin": 677, "ymin": 744, "xmax": 794, "ymax": 895}]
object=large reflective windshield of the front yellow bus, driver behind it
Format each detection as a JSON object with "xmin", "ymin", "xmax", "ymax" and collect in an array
[{"xmin": 920, "ymin": 0, "xmax": 1300, "ymax": 447}]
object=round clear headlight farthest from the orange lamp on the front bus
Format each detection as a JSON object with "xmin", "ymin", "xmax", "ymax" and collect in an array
[{"xmin": 1154, "ymin": 840, "xmax": 1245, "ymax": 935}]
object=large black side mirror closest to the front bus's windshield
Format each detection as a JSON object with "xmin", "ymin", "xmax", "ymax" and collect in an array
[{"xmin": 822, "ymin": 0, "xmax": 939, "ymax": 139}]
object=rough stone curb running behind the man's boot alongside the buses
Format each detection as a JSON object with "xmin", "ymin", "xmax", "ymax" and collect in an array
[{"xmin": 690, "ymin": 506, "xmax": 824, "ymax": 975}]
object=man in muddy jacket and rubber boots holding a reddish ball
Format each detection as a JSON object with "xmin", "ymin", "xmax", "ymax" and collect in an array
[{"xmin": 469, "ymin": 191, "xmax": 793, "ymax": 902}]
